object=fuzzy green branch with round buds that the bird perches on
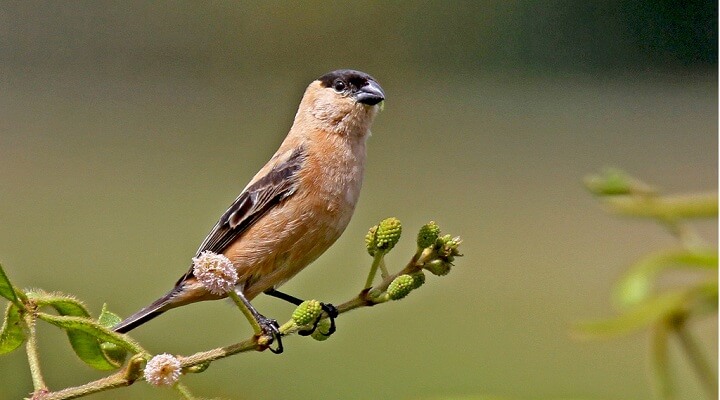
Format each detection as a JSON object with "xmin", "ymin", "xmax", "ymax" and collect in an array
[{"xmin": 14, "ymin": 218, "xmax": 461, "ymax": 400}]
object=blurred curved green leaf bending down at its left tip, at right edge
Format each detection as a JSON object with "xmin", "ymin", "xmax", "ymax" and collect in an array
[{"xmin": 613, "ymin": 249, "xmax": 718, "ymax": 308}]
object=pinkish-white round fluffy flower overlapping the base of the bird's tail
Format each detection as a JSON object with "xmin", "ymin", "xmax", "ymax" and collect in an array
[{"xmin": 193, "ymin": 251, "xmax": 238, "ymax": 295}]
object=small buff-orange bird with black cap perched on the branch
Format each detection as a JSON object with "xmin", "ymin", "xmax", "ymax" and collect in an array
[{"xmin": 113, "ymin": 70, "xmax": 385, "ymax": 352}]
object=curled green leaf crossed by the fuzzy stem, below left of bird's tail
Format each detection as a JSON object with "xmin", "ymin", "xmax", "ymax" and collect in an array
[{"xmin": 29, "ymin": 291, "xmax": 121, "ymax": 371}]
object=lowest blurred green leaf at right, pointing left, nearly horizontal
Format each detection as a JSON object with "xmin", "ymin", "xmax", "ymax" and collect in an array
[{"xmin": 573, "ymin": 290, "xmax": 691, "ymax": 339}]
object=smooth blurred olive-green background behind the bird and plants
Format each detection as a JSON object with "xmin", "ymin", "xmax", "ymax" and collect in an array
[{"xmin": 0, "ymin": 0, "xmax": 718, "ymax": 399}]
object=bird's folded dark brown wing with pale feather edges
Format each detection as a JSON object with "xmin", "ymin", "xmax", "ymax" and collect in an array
[{"xmin": 177, "ymin": 147, "xmax": 305, "ymax": 284}]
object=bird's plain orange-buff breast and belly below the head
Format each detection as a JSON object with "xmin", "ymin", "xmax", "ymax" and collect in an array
[{"xmin": 227, "ymin": 131, "xmax": 365, "ymax": 298}]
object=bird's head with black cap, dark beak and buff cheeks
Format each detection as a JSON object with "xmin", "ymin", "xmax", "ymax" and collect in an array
[{"xmin": 298, "ymin": 69, "xmax": 385, "ymax": 136}]
